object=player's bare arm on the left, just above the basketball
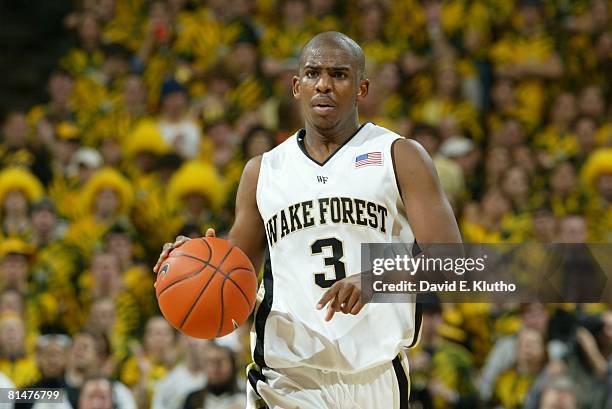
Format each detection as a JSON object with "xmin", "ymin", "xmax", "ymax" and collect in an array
[{"xmin": 228, "ymin": 156, "xmax": 266, "ymax": 271}]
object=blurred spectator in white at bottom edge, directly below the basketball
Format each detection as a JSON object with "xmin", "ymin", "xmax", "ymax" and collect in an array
[{"xmin": 151, "ymin": 335, "xmax": 210, "ymax": 409}]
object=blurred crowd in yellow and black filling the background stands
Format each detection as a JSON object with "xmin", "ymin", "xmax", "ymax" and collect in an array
[{"xmin": 0, "ymin": 0, "xmax": 612, "ymax": 409}]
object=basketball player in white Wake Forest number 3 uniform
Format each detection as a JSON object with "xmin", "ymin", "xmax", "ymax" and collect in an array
[{"xmin": 155, "ymin": 32, "xmax": 460, "ymax": 409}]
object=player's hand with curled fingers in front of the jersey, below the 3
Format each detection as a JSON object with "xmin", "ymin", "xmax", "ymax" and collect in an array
[{"xmin": 317, "ymin": 274, "xmax": 369, "ymax": 321}]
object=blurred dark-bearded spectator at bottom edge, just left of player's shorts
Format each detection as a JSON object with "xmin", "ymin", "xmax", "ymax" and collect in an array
[{"xmin": 183, "ymin": 343, "xmax": 246, "ymax": 409}]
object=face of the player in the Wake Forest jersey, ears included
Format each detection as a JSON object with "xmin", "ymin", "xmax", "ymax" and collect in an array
[{"xmin": 293, "ymin": 45, "xmax": 368, "ymax": 131}]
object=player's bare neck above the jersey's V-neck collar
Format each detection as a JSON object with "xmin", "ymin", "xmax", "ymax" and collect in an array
[{"xmin": 304, "ymin": 118, "xmax": 359, "ymax": 161}]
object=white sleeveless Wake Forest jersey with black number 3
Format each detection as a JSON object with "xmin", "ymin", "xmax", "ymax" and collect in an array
[{"xmin": 251, "ymin": 123, "xmax": 420, "ymax": 373}]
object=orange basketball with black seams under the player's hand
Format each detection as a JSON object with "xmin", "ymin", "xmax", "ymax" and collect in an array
[{"xmin": 155, "ymin": 237, "xmax": 257, "ymax": 339}]
